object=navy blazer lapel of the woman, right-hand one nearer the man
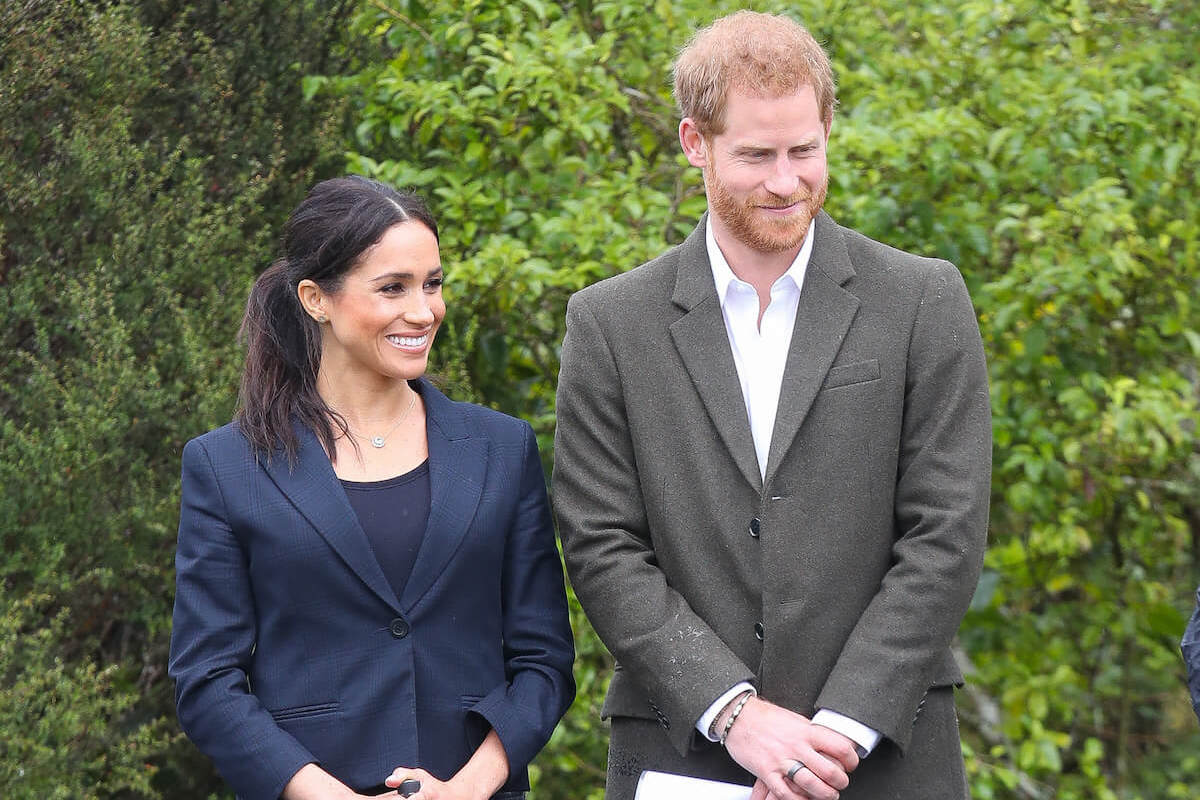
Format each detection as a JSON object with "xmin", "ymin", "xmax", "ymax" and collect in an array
[{"xmin": 400, "ymin": 378, "xmax": 488, "ymax": 612}]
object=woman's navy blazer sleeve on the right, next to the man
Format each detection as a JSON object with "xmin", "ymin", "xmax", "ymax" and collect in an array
[{"xmin": 472, "ymin": 422, "xmax": 575, "ymax": 776}]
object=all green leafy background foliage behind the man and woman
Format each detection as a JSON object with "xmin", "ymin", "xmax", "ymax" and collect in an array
[{"xmin": 0, "ymin": 0, "xmax": 1200, "ymax": 800}]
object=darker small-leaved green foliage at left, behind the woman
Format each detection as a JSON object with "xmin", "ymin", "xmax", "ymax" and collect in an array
[{"xmin": 0, "ymin": 0, "xmax": 349, "ymax": 800}]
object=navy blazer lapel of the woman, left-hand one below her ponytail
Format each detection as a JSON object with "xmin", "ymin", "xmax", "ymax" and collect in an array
[{"xmin": 260, "ymin": 423, "xmax": 400, "ymax": 612}]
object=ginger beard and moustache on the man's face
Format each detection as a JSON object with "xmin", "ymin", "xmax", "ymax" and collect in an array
[{"xmin": 704, "ymin": 155, "xmax": 829, "ymax": 253}]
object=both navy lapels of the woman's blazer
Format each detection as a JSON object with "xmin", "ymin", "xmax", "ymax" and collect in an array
[{"xmin": 262, "ymin": 378, "xmax": 487, "ymax": 612}]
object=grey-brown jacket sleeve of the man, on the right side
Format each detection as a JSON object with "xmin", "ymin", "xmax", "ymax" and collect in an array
[{"xmin": 816, "ymin": 261, "xmax": 991, "ymax": 750}]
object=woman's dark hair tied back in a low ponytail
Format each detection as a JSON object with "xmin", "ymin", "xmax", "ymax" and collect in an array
[{"xmin": 236, "ymin": 175, "xmax": 438, "ymax": 463}]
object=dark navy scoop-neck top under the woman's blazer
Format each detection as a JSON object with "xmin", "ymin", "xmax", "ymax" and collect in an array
[{"xmin": 342, "ymin": 459, "xmax": 430, "ymax": 597}]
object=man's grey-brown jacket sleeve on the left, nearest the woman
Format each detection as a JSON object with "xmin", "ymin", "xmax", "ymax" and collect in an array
[{"xmin": 553, "ymin": 295, "xmax": 755, "ymax": 754}]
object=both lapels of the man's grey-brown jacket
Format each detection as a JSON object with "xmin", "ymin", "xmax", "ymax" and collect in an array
[{"xmin": 671, "ymin": 211, "xmax": 858, "ymax": 492}]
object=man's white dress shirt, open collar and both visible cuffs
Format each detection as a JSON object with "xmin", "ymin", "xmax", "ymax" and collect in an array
[{"xmin": 696, "ymin": 217, "xmax": 881, "ymax": 757}]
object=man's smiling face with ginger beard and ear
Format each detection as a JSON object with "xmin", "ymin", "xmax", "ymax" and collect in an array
[{"xmin": 692, "ymin": 86, "xmax": 829, "ymax": 253}]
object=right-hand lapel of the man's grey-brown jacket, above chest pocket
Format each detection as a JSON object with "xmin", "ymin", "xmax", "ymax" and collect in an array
[{"xmin": 767, "ymin": 211, "xmax": 858, "ymax": 479}]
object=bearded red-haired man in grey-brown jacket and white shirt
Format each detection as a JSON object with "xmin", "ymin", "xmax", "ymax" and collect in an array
[{"xmin": 554, "ymin": 12, "xmax": 991, "ymax": 800}]
